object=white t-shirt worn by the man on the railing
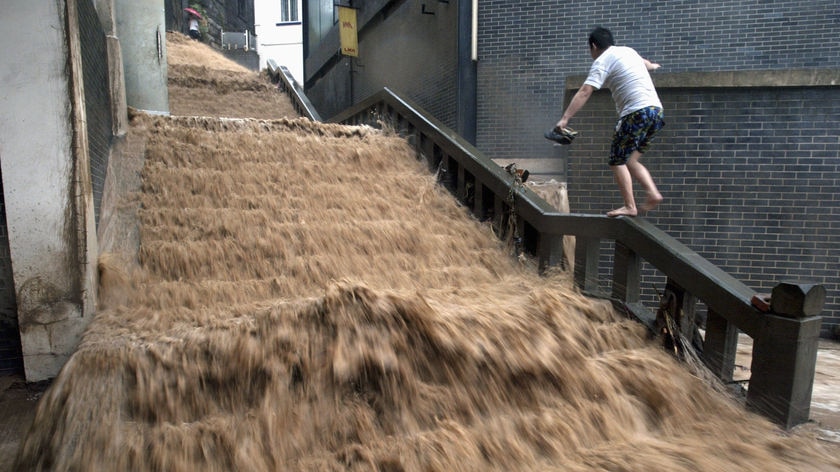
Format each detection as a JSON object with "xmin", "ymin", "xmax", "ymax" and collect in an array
[{"xmin": 584, "ymin": 46, "xmax": 662, "ymax": 117}]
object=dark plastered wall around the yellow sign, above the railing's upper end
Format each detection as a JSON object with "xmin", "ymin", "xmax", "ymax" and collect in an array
[{"xmin": 306, "ymin": 0, "xmax": 458, "ymax": 128}]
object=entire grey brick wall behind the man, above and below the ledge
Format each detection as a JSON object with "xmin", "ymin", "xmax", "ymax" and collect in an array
[{"xmin": 477, "ymin": 0, "xmax": 840, "ymax": 336}]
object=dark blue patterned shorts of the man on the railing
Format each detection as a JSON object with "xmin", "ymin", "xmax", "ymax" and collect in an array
[{"xmin": 610, "ymin": 107, "xmax": 665, "ymax": 166}]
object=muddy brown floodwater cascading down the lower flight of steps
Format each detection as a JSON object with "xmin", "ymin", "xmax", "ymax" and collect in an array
[{"xmin": 9, "ymin": 34, "xmax": 840, "ymax": 472}]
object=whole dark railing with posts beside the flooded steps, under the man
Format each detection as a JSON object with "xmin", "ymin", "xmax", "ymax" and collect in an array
[{"xmin": 332, "ymin": 88, "xmax": 824, "ymax": 427}]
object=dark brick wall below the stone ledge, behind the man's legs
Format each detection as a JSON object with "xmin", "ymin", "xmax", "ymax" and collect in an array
[{"xmin": 569, "ymin": 87, "xmax": 840, "ymax": 337}]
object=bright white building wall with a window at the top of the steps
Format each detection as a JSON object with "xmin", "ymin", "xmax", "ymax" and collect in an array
[{"xmin": 254, "ymin": 0, "xmax": 303, "ymax": 84}]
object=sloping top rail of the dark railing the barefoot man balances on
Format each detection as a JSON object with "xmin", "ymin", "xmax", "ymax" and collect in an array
[{"xmin": 329, "ymin": 88, "xmax": 762, "ymax": 336}]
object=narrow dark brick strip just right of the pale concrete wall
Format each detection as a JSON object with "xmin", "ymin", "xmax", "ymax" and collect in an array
[{"xmin": 78, "ymin": 0, "xmax": 112, "ymax": 226}]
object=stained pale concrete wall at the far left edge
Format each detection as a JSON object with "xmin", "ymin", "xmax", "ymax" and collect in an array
[{"xmin": 0, "ymin": 0, "xmax": 96, "ymax": 381}]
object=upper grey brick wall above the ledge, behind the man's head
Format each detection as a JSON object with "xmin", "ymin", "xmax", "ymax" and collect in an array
[{"xmin": 477, "ymin": 0, "xmax": 840, "ymax": 159}]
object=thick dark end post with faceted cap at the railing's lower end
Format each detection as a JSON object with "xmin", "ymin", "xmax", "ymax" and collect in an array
[{"xmin": 747, "ymin": 283, "xmax": 825, "ymax": 428}]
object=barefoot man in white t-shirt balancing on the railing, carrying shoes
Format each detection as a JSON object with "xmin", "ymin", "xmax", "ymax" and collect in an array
[{"xmin": 546, "ymin": 27, "xmax": 665, "ymax": 216}]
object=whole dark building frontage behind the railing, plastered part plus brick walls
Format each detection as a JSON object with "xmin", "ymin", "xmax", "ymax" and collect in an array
[{"xmin": 304, "ymin": 0, "xmax": 840, "ymax": 337}]
